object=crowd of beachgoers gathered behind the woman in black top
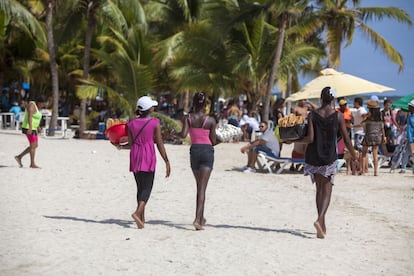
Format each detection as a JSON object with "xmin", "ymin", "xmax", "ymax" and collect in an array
[{"xmin": 218, "ymin": 93, "xmax": 414, "ymax": 176}]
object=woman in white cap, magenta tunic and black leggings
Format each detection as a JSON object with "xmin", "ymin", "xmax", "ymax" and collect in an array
[{"xmin": 117, "ymin": 96, "xmax": 171, "ymax": 229}]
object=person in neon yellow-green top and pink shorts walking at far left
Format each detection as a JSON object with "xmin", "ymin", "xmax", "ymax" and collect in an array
[{"xmin": 14, "ymin": 96, "xmax": 46, "ymax": 169}]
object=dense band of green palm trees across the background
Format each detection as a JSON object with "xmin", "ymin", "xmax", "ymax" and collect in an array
[{"xmin": 0, "ymin": 0, "xmax": 412, "ymax": 132}]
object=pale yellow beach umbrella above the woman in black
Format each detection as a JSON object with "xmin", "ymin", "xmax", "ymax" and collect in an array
[{"xmin": 286, "ymin": 68, "xmax": 395, "ymax": 101}]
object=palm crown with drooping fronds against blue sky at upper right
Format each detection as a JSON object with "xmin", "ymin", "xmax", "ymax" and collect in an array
[{"xmin": 314, "ymin": 0, "xmax": 412, "ymax": 71}]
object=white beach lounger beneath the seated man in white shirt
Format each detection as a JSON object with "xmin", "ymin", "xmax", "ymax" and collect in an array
[{"xmin": 257, "ymin": 151, "xmax": 305, "ymax": 174}]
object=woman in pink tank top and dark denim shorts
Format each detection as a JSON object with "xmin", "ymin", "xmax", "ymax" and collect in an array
[{"xmin": 178, "ymin": 93, "xmax": 216, "ymax": 230}]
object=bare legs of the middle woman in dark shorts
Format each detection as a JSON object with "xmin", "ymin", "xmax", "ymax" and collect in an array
[{"xmin": 193, "ymin": 168, "xmax": 211, "ymax": 230}]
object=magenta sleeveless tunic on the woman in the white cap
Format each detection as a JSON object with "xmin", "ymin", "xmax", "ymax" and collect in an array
[{"xmin": 127, "ymin": 118, "xmax": 159, "ymax": 172}]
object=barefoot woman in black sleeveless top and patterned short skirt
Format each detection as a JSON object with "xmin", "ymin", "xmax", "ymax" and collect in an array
[{"xmin": 295, "ymin": 87, "xmax": 358, "ymax": 239}]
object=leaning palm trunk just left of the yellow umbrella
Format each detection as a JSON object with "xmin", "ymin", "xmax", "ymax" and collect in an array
[{"xmin": 263, "ymin": 15, "xmax": 287, "ymax": 121}]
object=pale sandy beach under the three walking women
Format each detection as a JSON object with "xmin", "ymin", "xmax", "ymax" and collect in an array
[{"xmin": 0, "ymin": 131, "xmax": 414, "ymax": 275}]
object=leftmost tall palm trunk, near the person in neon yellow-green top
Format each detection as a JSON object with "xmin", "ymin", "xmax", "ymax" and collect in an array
[{"xmin": 46, "ymin": 0, "xmax": 59, "ymax": 136}]
